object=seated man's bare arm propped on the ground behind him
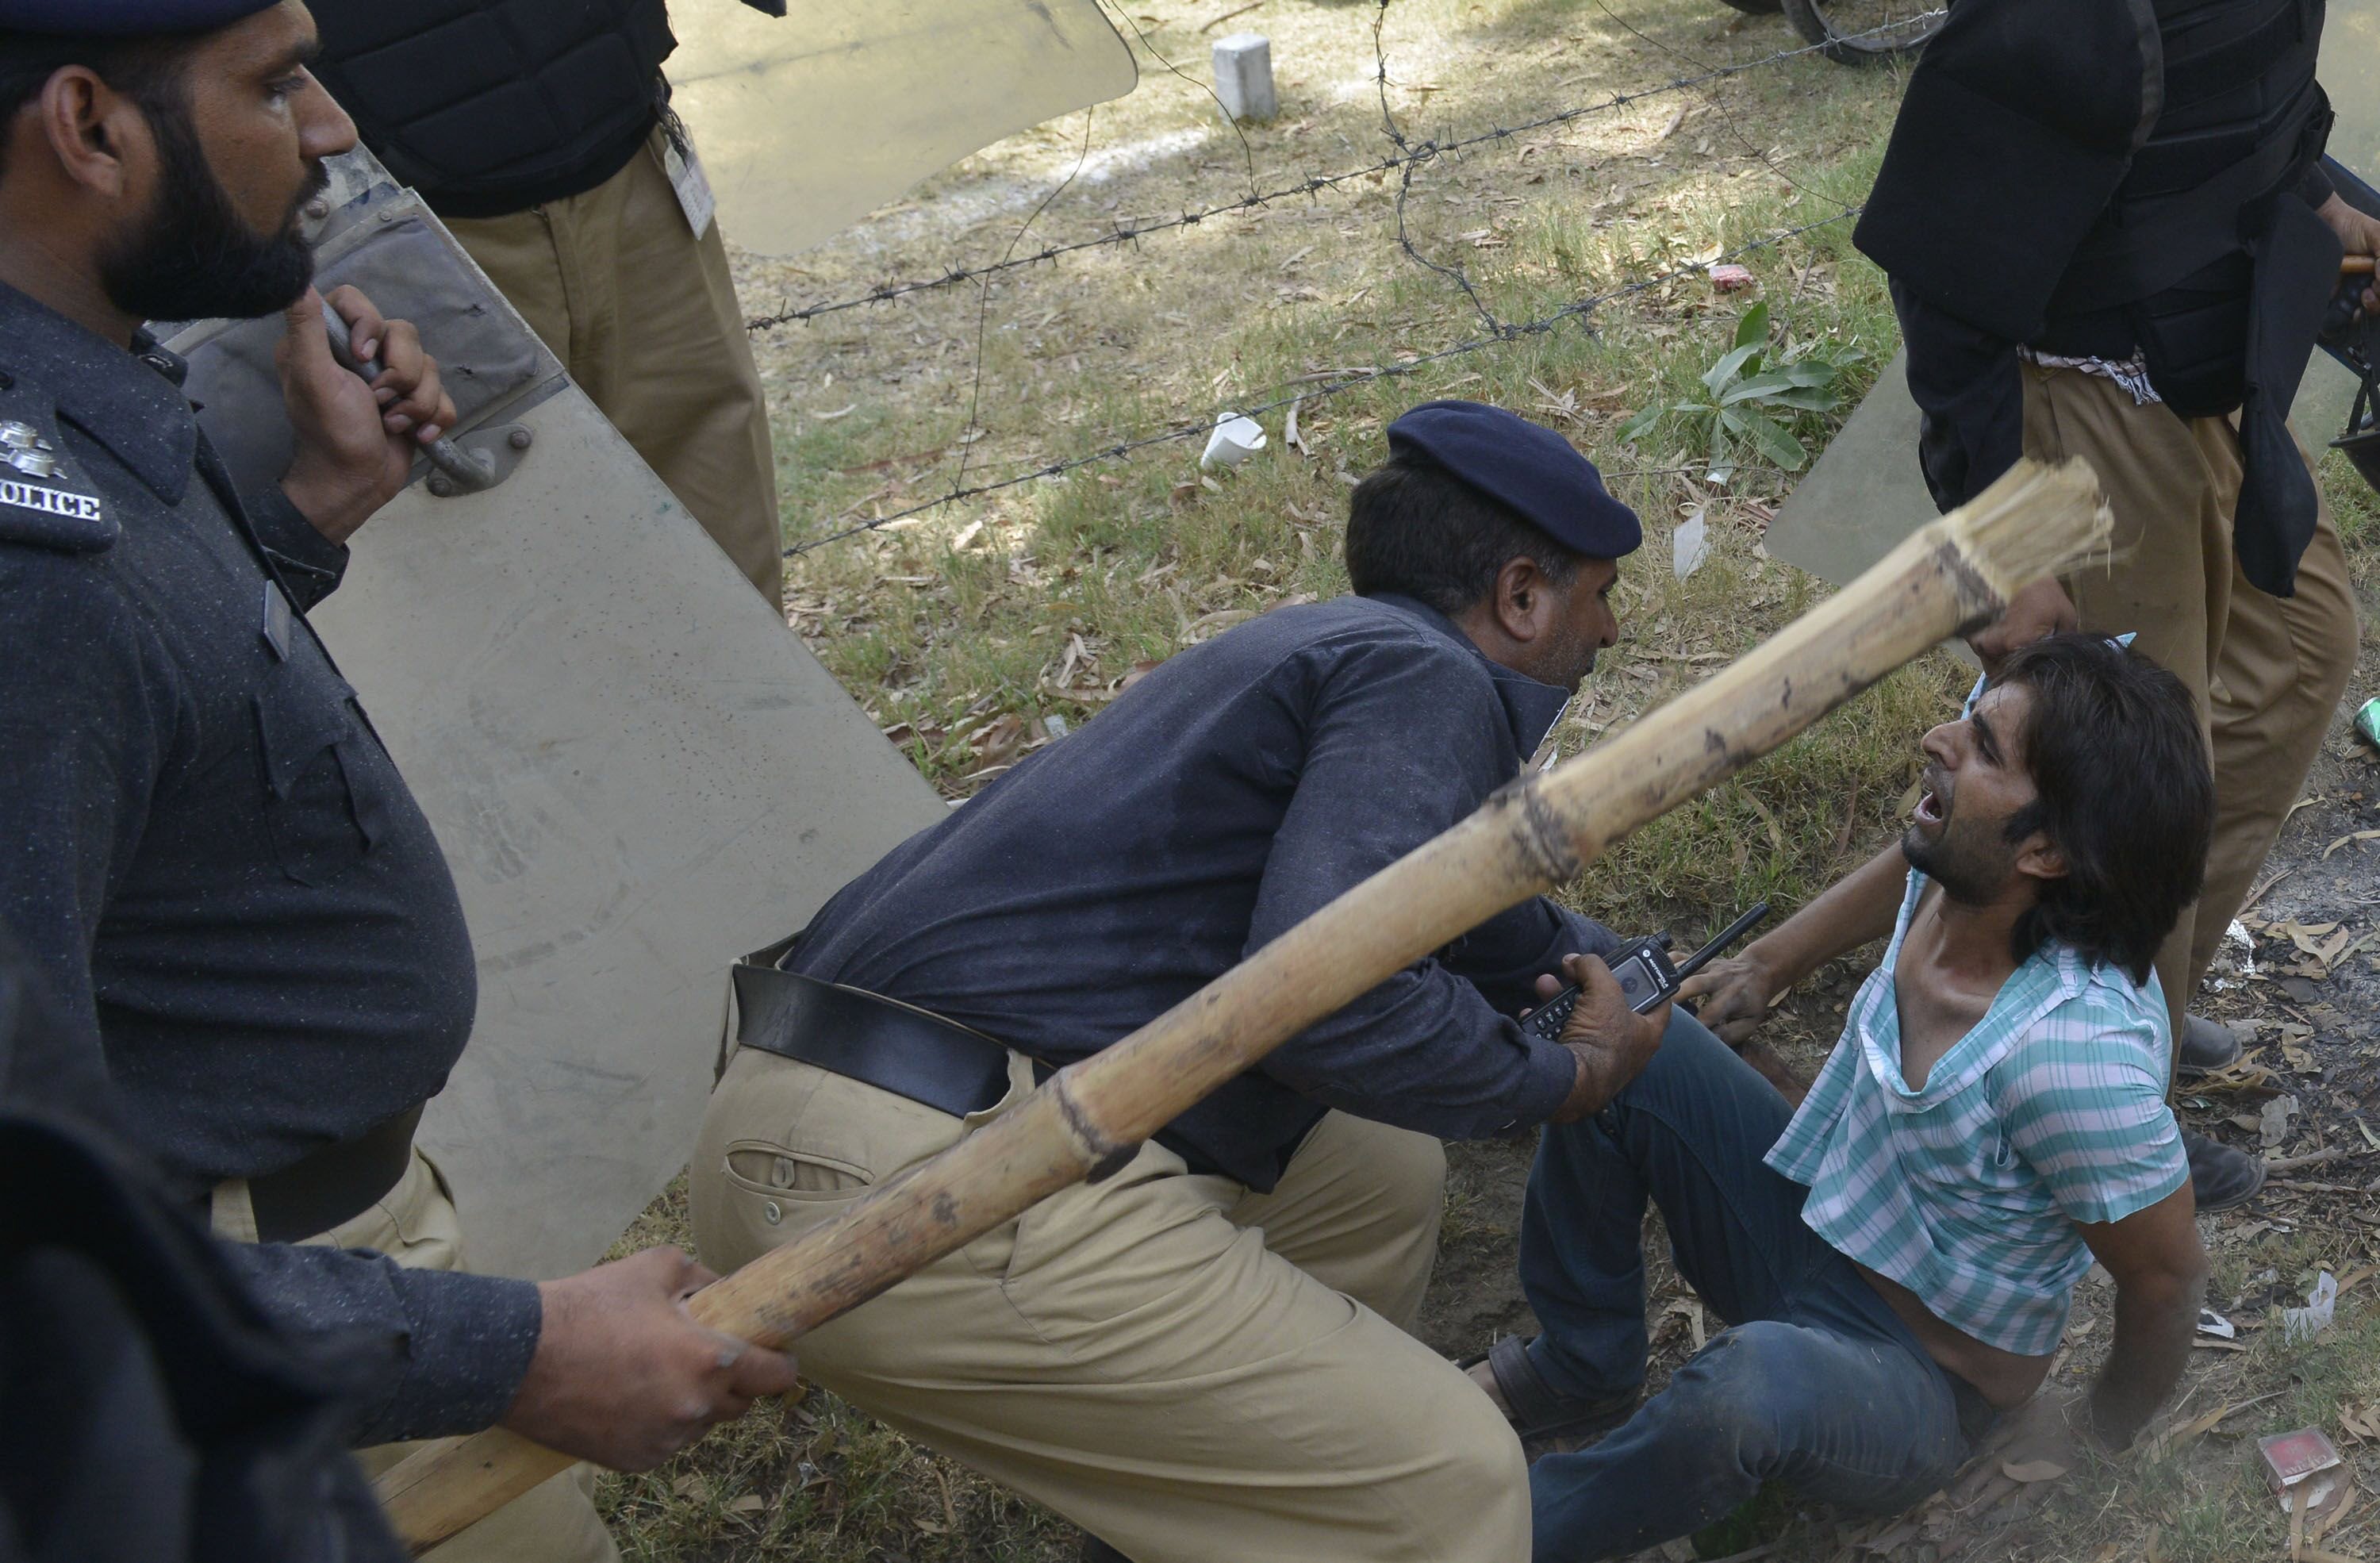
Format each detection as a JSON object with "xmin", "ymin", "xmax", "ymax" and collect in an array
[{"xmin": 2082, "ymin": 1182, "xmax": 2206, "ymax": 1449}]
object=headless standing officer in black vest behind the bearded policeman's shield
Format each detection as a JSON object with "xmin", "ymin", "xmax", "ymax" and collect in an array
[{"xmin": 312, "ymin": 0, "xmax": 785, "ymax": 607}]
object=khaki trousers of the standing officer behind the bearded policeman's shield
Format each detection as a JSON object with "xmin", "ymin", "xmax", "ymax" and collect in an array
[{"xmin": 447, "ymin": 129, "xmax": 783, "ymax": 605}]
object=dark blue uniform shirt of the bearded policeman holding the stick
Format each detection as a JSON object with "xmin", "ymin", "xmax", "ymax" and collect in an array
[{"xmin": 0, "ymin": 286, "xmax": 540, "ymax": 1439}]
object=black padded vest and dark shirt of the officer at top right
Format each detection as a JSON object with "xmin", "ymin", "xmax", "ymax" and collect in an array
[{"xmin": 1854, "ymin": 0, "xmax": 2340, "ymax": 597}]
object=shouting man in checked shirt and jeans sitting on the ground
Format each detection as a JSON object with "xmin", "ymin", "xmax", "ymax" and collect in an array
[{"xmin": 1478, "ymin": 633, "xmax": 2213, "ymax": 1563}]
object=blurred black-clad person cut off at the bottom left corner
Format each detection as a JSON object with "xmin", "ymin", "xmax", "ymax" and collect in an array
[{"xmin": 0, "ymin": 927, "xmax": 405, "ymax": 1563}]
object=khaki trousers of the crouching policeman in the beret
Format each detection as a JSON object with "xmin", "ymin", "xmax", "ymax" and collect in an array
[{"xmin": 690, "ymin": 1049, "xmax": 1528, "ymax": 1563}]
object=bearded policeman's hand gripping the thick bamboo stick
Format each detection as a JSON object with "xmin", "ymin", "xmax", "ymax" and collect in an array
[{"xmin": 505, "ymin": 1249, "xmax": 800, "ymax": 1470}]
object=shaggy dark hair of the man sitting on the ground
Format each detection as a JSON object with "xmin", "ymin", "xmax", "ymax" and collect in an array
[{"xmin": 1997, "ymin": 633, "xmax": 2216, "ymax": 975}]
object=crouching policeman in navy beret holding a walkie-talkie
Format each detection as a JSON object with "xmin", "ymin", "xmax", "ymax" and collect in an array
[{"xmin": 690, "ymin": 402, "xmax": 1661, "ymax": 1563}]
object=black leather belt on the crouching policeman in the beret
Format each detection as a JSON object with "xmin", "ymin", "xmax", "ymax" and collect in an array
[{"xmin": 735, "ymin": 961, "xmax": 1009, "ymax": 1118}]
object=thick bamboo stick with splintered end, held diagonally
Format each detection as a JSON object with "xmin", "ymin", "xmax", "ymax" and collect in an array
[{"xmin": 378, "ymin": 462, "xmax": 2109, "ymax": 1549}]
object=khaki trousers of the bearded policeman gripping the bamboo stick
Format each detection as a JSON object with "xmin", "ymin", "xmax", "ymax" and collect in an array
[{"xmin": 214, "ymin": 1146, "xmax": 619, "ymax": 1563}]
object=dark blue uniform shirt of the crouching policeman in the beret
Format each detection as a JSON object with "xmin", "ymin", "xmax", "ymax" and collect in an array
[{"xmin": 785, "ymin": 597, "xmax": 1614, "ymax": 1189}]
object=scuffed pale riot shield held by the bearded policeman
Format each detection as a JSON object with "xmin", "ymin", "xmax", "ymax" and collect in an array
[{"xmin": 171, "ymin": 150, "xmax": 945, "ymax": 1277}]
